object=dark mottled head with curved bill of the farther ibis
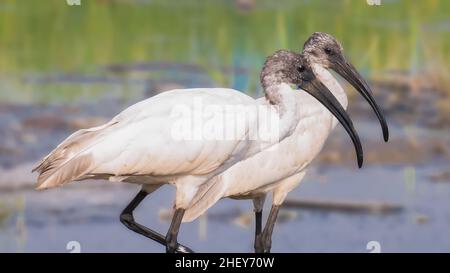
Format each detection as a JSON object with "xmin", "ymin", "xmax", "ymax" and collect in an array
[{"xmin": 303, "ymin": 32, "xmax": 389, "ymax": 141}]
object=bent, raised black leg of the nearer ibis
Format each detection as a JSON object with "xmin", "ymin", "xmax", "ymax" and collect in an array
[{"xmin": 120, "ymin": 191, "xmax": 193, "ymax": 253}]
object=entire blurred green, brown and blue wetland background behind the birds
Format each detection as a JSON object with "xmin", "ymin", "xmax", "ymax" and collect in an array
[{"xmin": 0, "ymin": 0, "xmax": 450, "ymax": 252}]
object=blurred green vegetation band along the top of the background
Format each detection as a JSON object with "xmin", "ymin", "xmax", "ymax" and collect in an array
[{"xmin": 0, "ymin": 0, "xmax": 450, "ymax": 101}]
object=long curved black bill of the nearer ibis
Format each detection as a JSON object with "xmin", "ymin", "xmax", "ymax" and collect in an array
[{"xmin": 301, "ymin": 79, "xmax": 364, "ymax": 168}]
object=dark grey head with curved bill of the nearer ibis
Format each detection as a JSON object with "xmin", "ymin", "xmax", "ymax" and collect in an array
[{"xmin": 261, "ymin": 50, "xmax": 363, "ymax": 167}]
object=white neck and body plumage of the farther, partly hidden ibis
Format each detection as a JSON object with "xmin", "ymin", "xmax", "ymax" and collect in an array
[{"xmin": 183, "ymin": 64, "xmax": 347, "ymax": 221}]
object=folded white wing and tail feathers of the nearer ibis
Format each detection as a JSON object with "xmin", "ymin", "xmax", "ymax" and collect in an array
[{"xmin": 35, "ymin": 88, "xmax": 256, "ymax": 189}]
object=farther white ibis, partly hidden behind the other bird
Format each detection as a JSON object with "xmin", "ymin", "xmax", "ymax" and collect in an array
[{"xmin": 183, "ymin": 32, "xmax": 389, "ymax": 252}]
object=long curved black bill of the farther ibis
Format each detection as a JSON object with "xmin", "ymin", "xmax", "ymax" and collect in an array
[{"xmin": 331, "ymin": 57, "xmax": 389, "ymax": 142}]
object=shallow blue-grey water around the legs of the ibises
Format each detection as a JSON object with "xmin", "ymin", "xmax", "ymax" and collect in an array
[{"xmin": 0, "ymin": 158, "xmax": 450, "ymax": 252}]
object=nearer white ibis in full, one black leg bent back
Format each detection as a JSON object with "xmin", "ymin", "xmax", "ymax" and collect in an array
[{"xmin": 34, "ymin": 51, "xmax": 348, "ymax": 252}]
